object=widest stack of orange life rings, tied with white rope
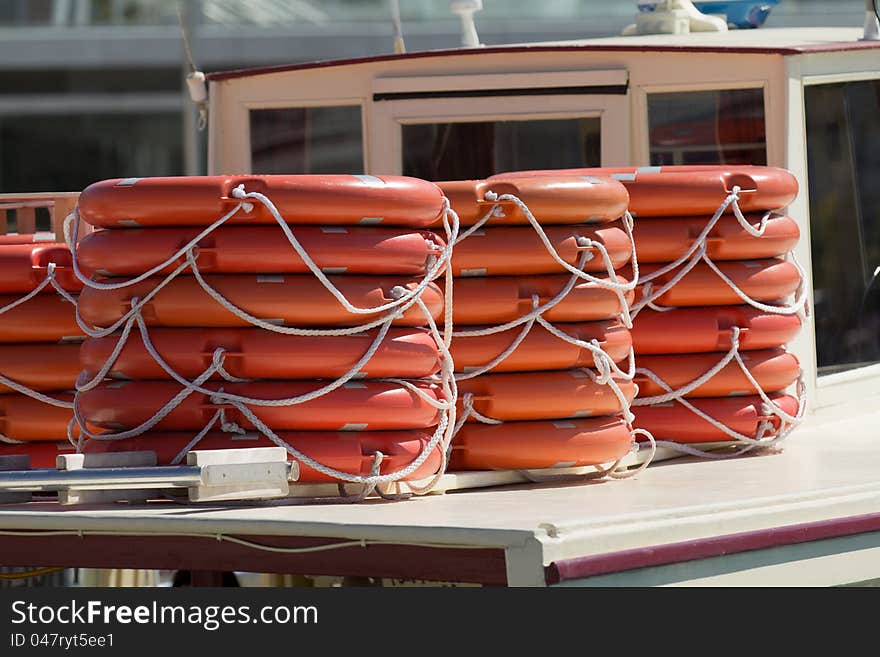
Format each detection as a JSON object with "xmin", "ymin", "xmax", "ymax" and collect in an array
[{"xmin": 65, "ymin": 175, "xmax": 455, "ymax": 490}]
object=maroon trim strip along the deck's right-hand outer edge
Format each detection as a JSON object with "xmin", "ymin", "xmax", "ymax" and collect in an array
[{"xmin": 544, "ymin": 513, "xmax": 880, "ymax": 584}]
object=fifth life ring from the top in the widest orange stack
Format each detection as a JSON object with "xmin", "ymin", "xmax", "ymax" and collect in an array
[{"xmin": 77, "ymin": 381, "xmax": 442, "ymax": 431}]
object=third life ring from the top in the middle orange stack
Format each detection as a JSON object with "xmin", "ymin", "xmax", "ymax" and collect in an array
[{"xmin": 446, "ymin": 274, "xmax": 634, "ymax": 329}]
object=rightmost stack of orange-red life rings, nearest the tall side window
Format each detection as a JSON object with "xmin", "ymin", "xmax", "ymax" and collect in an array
[{"xmin": 492, "ymin": 165, "xmax": 805, "ymax": 454}]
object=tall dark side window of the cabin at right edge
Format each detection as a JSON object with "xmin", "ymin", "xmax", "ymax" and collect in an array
[{"xmin": 804, "ymin": 80, "xmax": 880, "ymax": 374}]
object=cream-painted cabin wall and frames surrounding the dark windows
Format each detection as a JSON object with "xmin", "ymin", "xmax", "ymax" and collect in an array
[{"xmin": 209, "ymin": 49, "xmax": 880, "ymax": 416}]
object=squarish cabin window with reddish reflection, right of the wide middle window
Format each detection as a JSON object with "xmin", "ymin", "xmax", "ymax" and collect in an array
[{"xmin": 648, "ymin": 89, "xmax": 767, "ymax": 166}]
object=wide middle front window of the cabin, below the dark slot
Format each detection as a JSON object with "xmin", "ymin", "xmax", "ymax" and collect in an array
[{"xmin": 402, "ymin": 117, "xmax": 602, "ymax": 180}]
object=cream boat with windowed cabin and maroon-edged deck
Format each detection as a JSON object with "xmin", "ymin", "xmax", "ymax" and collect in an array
[{"xmin": 0, "ymin": 28, "xmax": 880, "ymax": 586}]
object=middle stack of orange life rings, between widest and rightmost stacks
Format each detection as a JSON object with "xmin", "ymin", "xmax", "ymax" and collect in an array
[{"xmin": 437, "ymin": 176, "xmax": 635, "ymax": 470}]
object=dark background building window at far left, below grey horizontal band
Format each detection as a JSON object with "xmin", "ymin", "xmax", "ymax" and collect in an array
[{"xmin": 0, "ymin": 113, "xmax": 183, "ymax": 193}]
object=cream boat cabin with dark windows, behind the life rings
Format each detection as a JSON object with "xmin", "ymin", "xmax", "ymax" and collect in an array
[{"xmin": 208, "ymin": 28, "xmax": 880, "ymax": 420}]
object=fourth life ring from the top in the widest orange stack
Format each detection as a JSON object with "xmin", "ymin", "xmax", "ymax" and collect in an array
[{"xmin": 81, "ymin": 328, "xmax": 440, "ymax": 379}]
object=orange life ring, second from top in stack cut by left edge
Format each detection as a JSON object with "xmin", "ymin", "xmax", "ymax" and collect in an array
[{"xmin": 0, "ymin": 294, "xmax": 83, "ymax": 343}]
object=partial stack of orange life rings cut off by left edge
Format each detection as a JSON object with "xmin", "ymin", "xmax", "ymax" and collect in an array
[{"xmin": 0, "ymin": 241, "xmax": 83, "ymax": 468}]
